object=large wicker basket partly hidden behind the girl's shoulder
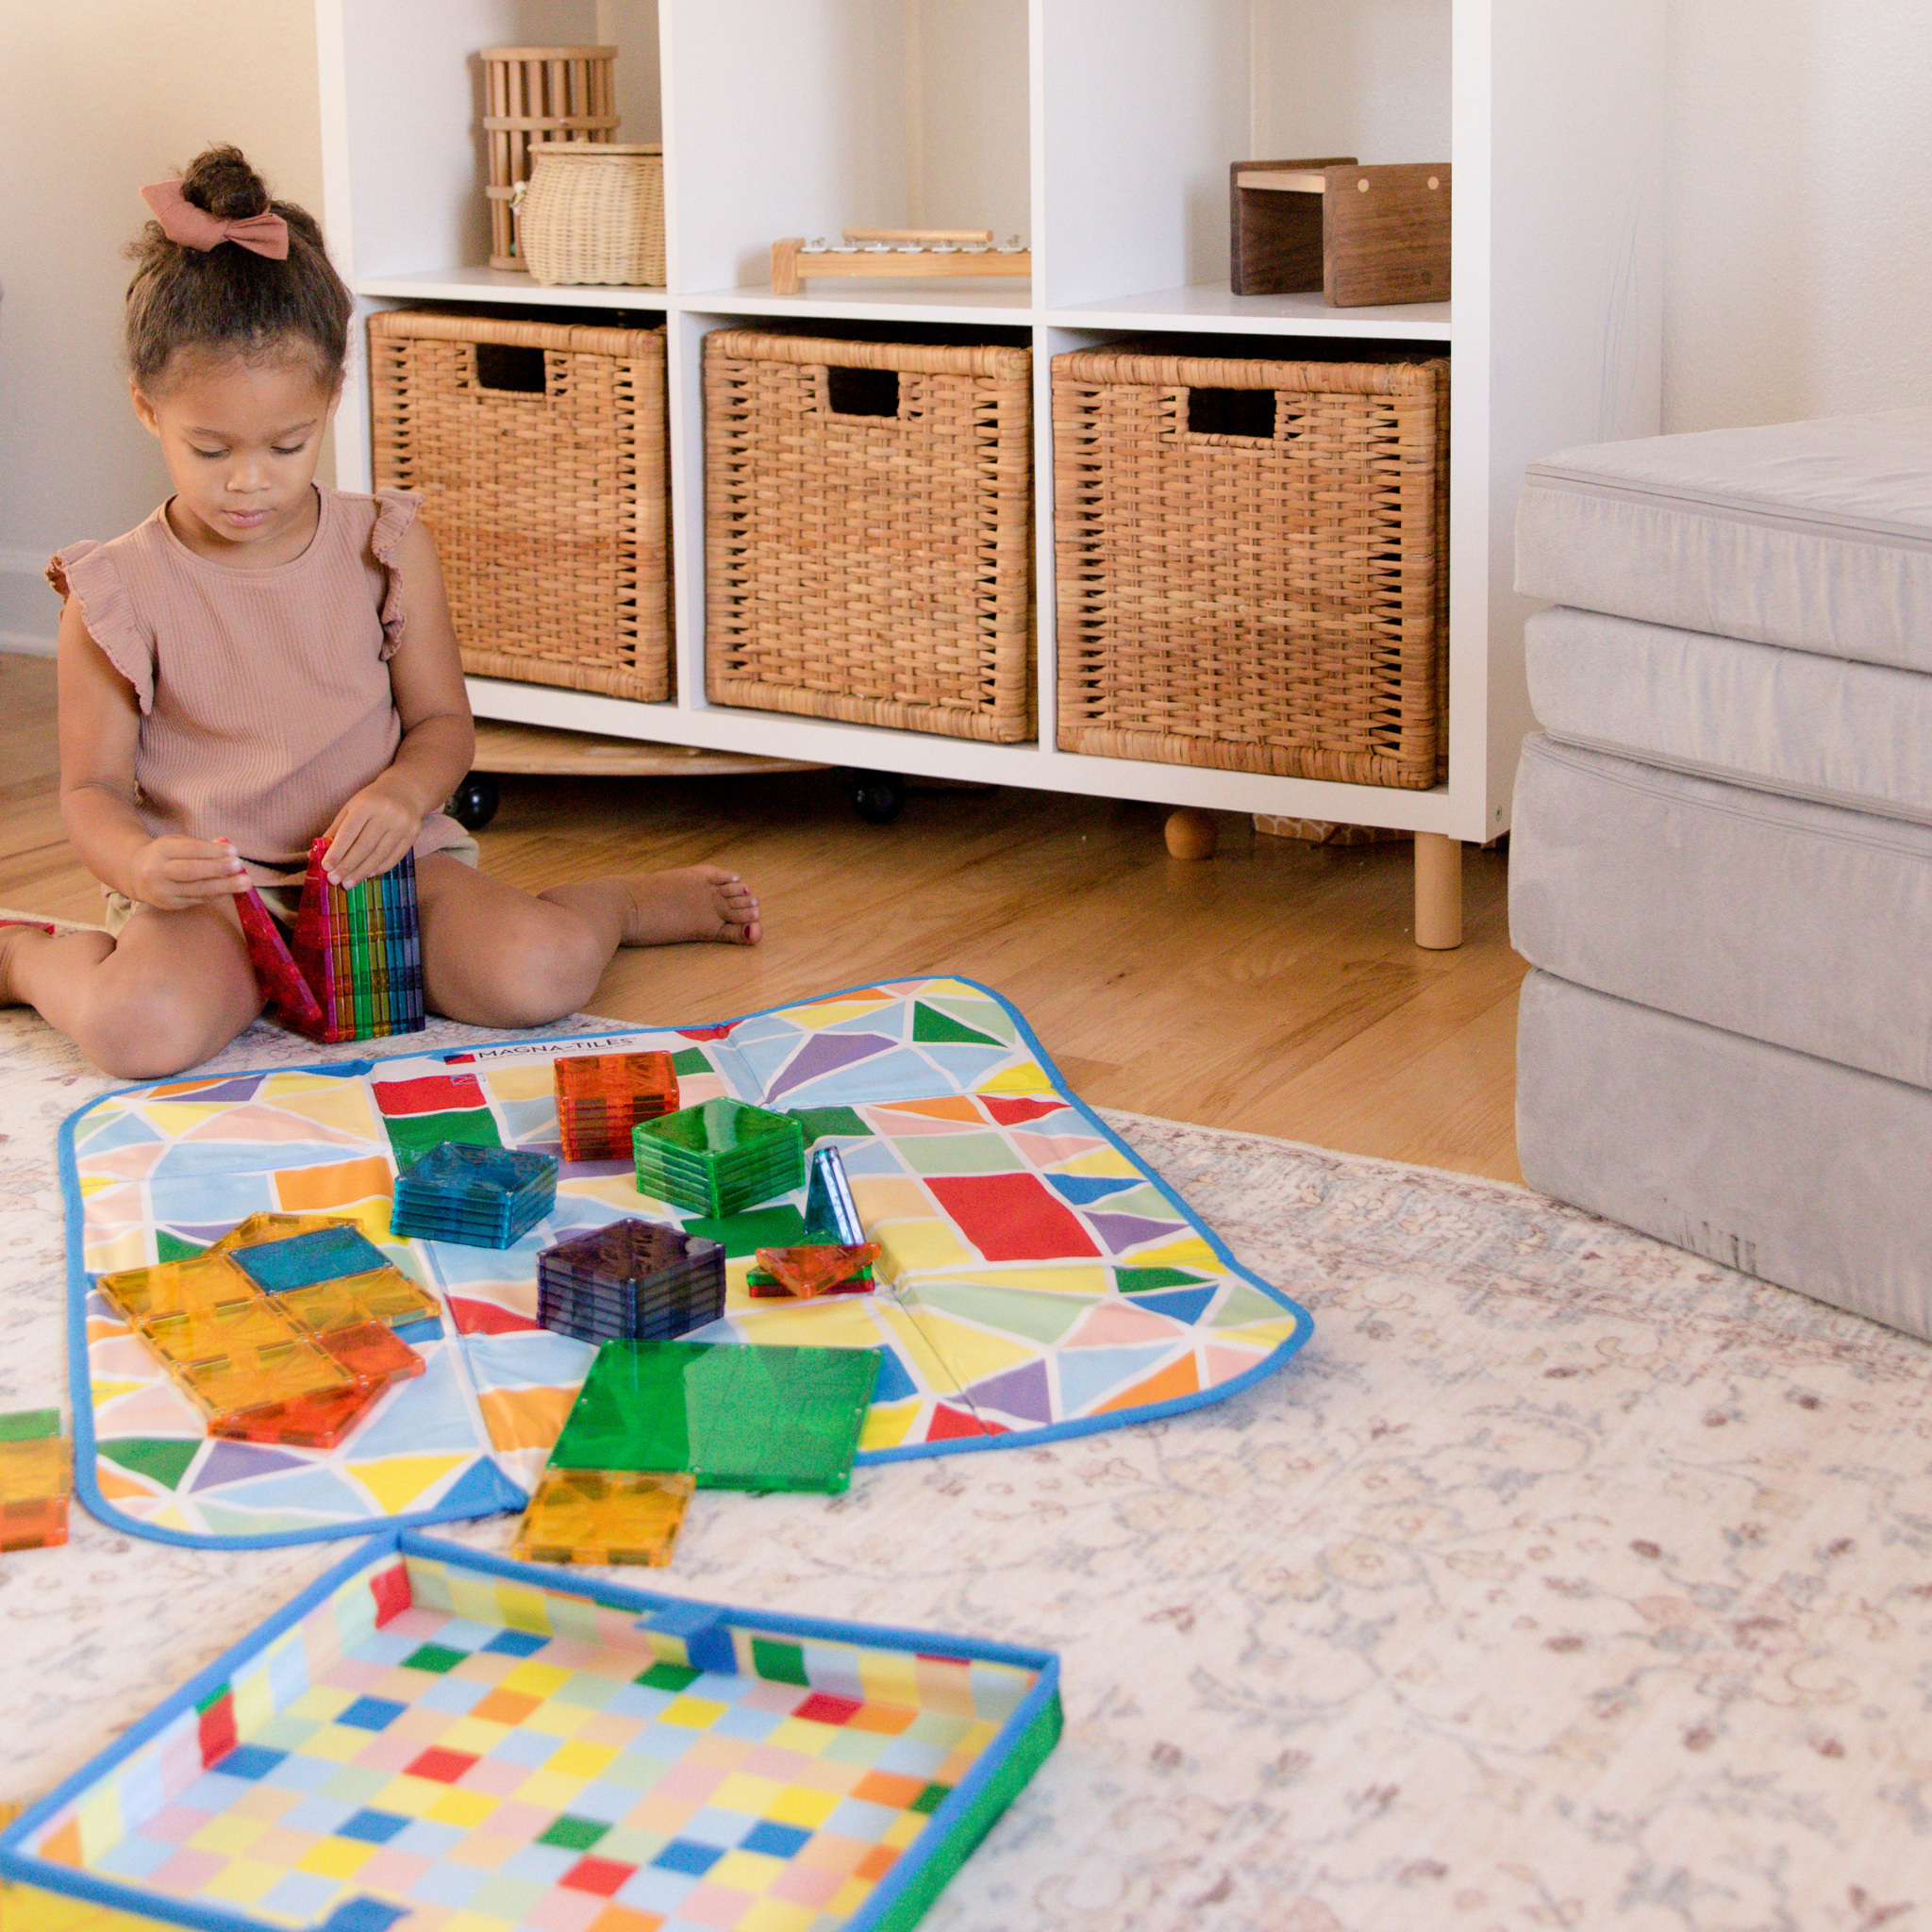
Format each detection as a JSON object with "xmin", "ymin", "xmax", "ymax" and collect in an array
[{"xmin": 369, "ymin": 309, "xmax": 671, "ymax": 701}]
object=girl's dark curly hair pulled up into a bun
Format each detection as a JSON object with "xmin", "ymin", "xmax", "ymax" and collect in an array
[{"xmin": 125, "ymin": 147, "xmax": 352, "ymax": 392}]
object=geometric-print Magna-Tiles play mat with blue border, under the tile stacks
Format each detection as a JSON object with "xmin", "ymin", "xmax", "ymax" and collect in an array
[{"xmin": 59, "ymin": 977, "xmax": 1310, "ymax": 1547}]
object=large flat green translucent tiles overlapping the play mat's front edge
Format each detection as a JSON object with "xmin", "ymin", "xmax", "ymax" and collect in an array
[{"xmin": 551, "ymin": 1341, "xmax": 881, "ymax": 1493}]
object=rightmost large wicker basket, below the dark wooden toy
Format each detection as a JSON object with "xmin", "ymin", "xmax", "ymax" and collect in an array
[{"xmin": 1053, "ymin": 344, "xmax": 1449, "ymax": 789}]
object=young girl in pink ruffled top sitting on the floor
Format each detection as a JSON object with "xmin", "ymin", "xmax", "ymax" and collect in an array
[{"xmin": 0, "ymin": 147, "xmax": 759, "ymax": 1080}]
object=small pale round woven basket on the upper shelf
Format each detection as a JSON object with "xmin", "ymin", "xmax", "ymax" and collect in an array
[{"xmin": 516, "ymin": 142, "xmax": 665, "ymax": 288}]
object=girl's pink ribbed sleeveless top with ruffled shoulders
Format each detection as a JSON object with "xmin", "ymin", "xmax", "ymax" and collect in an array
[{"xmin": 46, "ymin": 483, "xmax": 468, "ymax": 885}]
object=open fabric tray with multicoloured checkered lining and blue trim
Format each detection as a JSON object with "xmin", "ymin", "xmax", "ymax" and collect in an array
[{"xmin": 0, "ymin": 1528, "xmax": 1060, "ymax": 1932}]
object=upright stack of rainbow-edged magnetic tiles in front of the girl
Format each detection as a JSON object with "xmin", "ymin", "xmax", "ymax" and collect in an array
[{"xmin": 276, "ymin": 839, "xmax": 424, "ymax": 1045}]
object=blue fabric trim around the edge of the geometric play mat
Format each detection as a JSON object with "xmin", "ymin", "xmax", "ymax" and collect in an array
[{"xmin": 59, "ymin": 972, "xmax": 1314, "ymax": 1549}]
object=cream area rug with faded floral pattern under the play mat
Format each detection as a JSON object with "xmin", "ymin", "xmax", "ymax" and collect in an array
[{"xmin": 0, "ymin": 1012, "xmax": 1932, "ymax": 1932}]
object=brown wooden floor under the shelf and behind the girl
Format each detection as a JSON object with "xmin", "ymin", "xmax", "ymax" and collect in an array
[{"xmin": 0, "ymin": 655, "xmax": 1524, "ymax": 1180}]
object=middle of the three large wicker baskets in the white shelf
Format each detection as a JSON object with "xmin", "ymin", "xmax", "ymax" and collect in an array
[{"xmin": 706, "ymin": 328, "xmax": 1034, "ymax": 743}]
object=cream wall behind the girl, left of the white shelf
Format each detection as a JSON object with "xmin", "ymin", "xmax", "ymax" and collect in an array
[{"xmin": 0, "ymin": 0, "xmax": 323, "ymax": 647}]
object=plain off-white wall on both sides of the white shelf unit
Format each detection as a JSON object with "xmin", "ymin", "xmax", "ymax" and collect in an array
[{"xmin": 0, "ymin": 0, "xmax": 1932, "ymax": 645}]
